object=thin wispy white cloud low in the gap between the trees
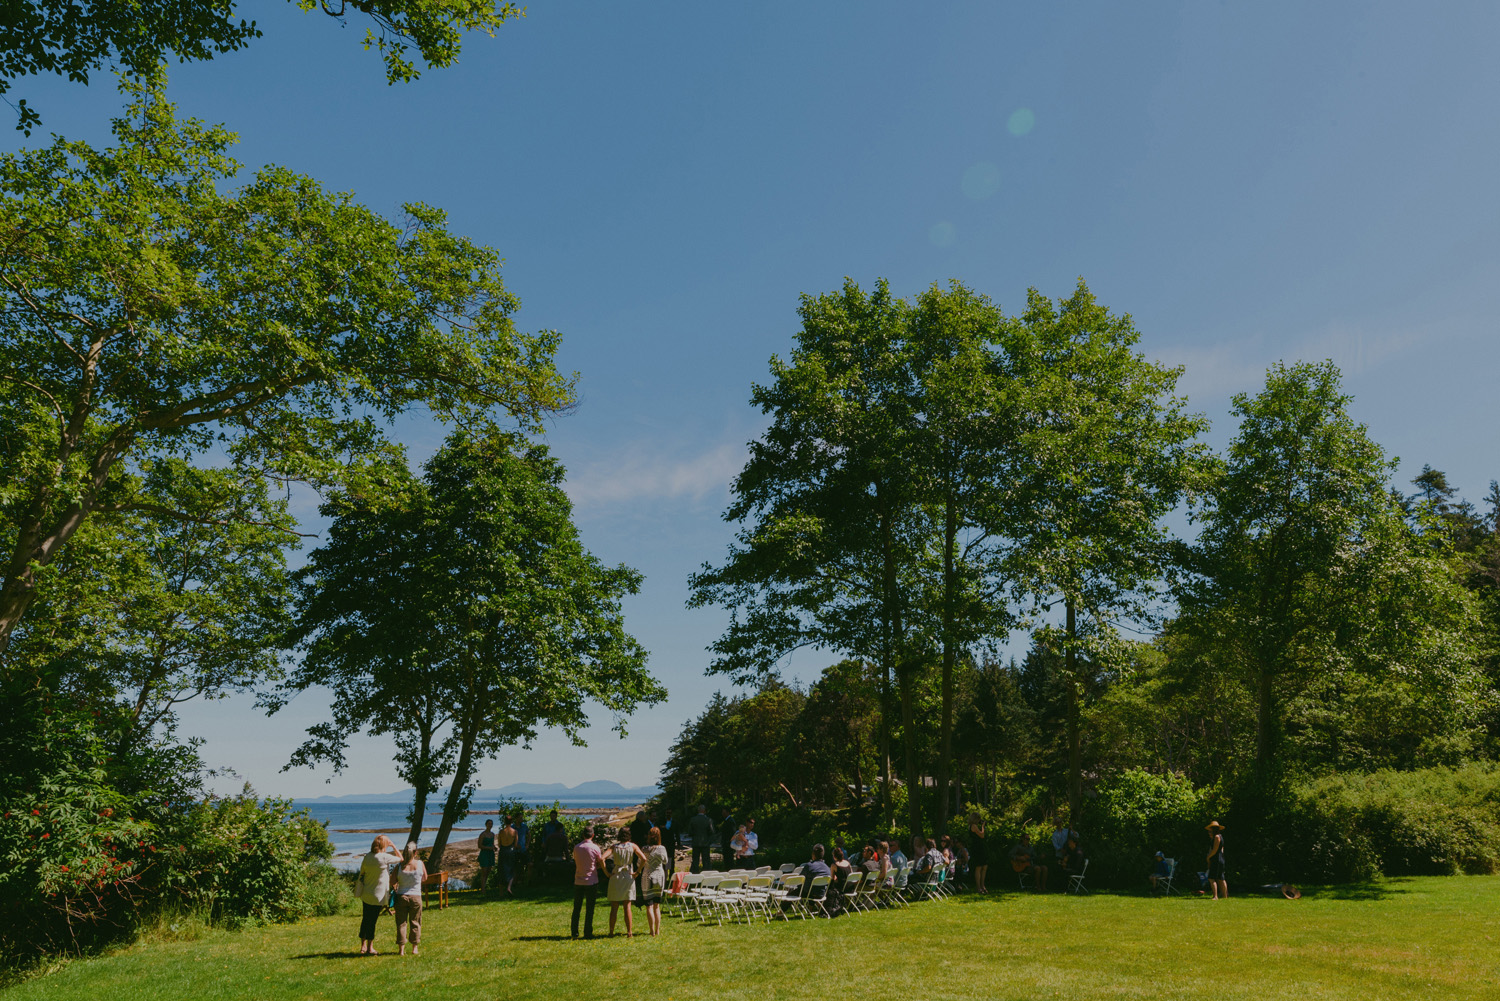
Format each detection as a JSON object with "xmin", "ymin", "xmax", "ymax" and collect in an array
[{"xmin": 567, "ymin": 443, "xmax": 746, "ymax": 510}]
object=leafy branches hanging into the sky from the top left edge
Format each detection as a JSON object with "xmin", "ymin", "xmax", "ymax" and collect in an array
[{"xmin": 0, "ymin": 0, "xmax": 525, "ymax": 135}]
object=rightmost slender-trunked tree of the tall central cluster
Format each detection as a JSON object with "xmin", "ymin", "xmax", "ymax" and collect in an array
[{"xmin": 1007, "ymin": 279, "xmax": 1208, "ymax": 818}]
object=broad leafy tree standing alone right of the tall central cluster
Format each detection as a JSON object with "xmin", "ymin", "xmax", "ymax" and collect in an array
[{"xmin": 1178, "ymin": 362, "xmax": 1479, "ymax": 789}]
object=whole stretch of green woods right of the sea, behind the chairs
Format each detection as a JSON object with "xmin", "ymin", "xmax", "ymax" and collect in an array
[{"xmin": 681, "ymin": 282, "xmax": 1500, "ymax": 870}]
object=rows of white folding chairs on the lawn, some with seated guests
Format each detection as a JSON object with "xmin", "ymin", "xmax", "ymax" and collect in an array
[{"xmin": 666, "ymin": 863, "xmax": 953, "ymax": 924}]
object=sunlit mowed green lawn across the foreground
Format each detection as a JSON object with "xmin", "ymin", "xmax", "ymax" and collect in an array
[{"xmin": 8, "ymin": 876, "xmax": 1500, "ymax": 1001}]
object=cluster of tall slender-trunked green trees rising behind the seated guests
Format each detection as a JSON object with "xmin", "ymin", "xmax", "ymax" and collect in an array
[{"xmin": 692, "ymin": 282, "xmax": 1202, "ymax": 828}]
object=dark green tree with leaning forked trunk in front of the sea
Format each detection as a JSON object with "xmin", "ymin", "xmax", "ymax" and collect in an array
[{"xmin": 291, "ymin": 431, "xmax": 666, "ymax": 867}]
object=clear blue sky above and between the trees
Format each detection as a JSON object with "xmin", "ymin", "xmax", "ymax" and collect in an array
[{"xmin": 5, "ymin": 0, "xmax": 1500, "ymax": 795}]
